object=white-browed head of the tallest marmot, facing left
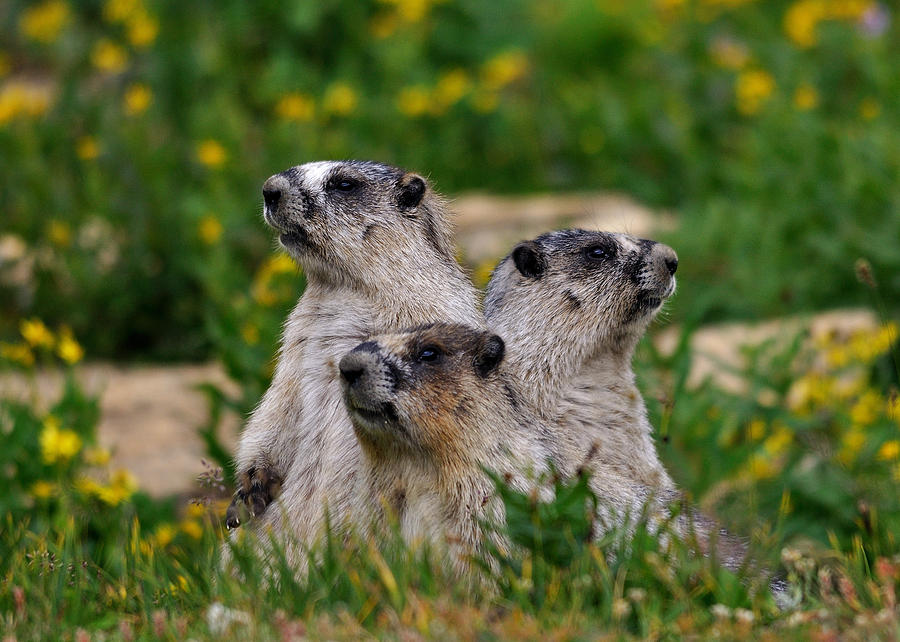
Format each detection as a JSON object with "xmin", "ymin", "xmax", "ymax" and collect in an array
[{"xmin": 263, "ymin": 161, "xmax": 454, "ymax": 281}]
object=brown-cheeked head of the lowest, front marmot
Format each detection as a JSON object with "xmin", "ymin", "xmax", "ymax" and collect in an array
[{"xmin": 339, "ymin": 323, "xmax": 506, "ymax": 459}]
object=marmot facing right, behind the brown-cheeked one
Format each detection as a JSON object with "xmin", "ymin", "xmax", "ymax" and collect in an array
[{"xmin": 484, "ymin": 230, "xmax": 678, "ymax": 490}]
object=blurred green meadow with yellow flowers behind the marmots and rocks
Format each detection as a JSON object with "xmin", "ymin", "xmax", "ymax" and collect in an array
[{"xmin": 0, "ymin": 0, "xmax": 900, "ymax": 360}]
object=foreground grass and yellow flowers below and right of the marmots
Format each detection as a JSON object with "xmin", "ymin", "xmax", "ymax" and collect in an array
[{"xmin": 0, "ymin": 312, "xmax": 900, "ymax": 640}]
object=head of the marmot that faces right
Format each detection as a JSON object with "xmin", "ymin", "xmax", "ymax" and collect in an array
[{"xmin": 484, "ymin": 230, "xmax": 678, "ymax": 355}]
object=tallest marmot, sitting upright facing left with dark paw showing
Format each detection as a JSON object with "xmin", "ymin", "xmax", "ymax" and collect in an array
[{"xmin": 226, "ymin": 161, "xmax": 484, "ymax": 543}]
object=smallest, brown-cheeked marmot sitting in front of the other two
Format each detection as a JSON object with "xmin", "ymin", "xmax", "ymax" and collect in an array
[{"xmin": 340, "ymin": 323, "xmax": 551, "ymax": 571}]
